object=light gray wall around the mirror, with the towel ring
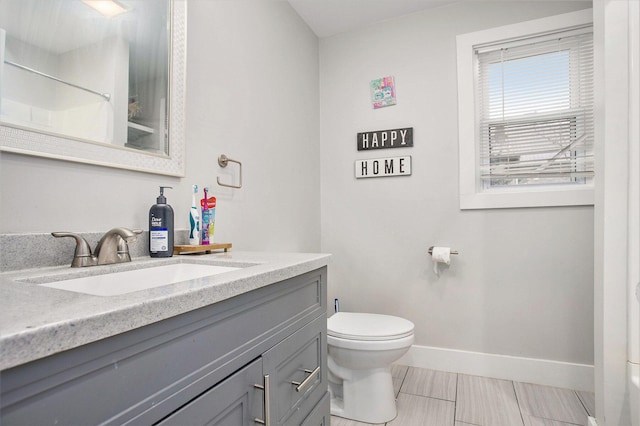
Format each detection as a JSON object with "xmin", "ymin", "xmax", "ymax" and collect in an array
[{"xmin": 0, "ymin": 1, "xmax": 320, "ymax": 255}]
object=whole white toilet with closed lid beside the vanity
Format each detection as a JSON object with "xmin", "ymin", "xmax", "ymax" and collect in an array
[{"xmin": 327, "ymin": 312, "xmax": 414, "ymax": 423}]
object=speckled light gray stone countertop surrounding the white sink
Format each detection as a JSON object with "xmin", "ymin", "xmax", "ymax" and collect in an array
[{"xmin": 0, "ymin": 251, "xmax": 330, "ymax": 370}]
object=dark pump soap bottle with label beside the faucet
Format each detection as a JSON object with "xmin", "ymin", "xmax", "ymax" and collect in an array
[{"xmin": 149, "ymin": 186, "xmax": 173, "ymax": 257}]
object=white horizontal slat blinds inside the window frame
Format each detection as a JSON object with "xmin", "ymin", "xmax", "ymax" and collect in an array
[{"xmin": 475, "ymin": 27, "xmax": 594, "ymax": 188}]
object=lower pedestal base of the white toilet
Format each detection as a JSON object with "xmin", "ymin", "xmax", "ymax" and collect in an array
[{"xmin": 329, "ymin": 367, "xmax": 398, "ymax": 423}]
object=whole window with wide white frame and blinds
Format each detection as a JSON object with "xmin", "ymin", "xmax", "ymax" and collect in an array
[{"xmin": 457, "ymin": 9, "xmax": 594, "ymax": 209}]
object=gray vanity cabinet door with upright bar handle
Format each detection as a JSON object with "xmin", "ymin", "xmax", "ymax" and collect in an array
[{"xmin": 157, "ymin": 358, "xmax": 263, "ymax": 426}]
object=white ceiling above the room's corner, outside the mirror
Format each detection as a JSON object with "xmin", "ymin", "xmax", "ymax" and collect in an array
[{"xmin": 288, "ymin": 0, "xmax": 459, "ymax": 38}]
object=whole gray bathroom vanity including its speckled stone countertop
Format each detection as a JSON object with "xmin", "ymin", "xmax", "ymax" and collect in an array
[{"xmin": 0, "ymin": 253, "xmax": 329, "ymax": 426}]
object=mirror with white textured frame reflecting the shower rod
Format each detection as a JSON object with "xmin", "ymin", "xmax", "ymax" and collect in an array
[{"xmin": 0, "ymin": 0, "xmax": 186, "ymax": 176}]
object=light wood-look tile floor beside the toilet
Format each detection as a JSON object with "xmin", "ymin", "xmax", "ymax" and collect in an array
[{"xmin": 331, "ymin": 365, "xmax": 595, "ymax": 426}]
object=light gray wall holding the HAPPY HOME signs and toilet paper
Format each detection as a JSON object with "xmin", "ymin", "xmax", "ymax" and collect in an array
[{"xmin": 320, "ymin": 2, "xmax": 593, "ymax": 365}]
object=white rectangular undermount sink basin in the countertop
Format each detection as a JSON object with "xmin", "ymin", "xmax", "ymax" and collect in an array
[{"xmin": 39, "ymin": 263, "xmax": 240, "ymax": 296}]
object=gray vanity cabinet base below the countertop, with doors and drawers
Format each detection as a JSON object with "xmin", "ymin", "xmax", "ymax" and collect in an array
[{"xmin": 0, "ymin": 267, "xmax": 329, "ymax": 426}]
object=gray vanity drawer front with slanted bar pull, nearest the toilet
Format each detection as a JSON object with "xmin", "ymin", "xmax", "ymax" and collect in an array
[{"xmin": 262, "ymin": 315, "xmax": 327, "ymax": 426}]
